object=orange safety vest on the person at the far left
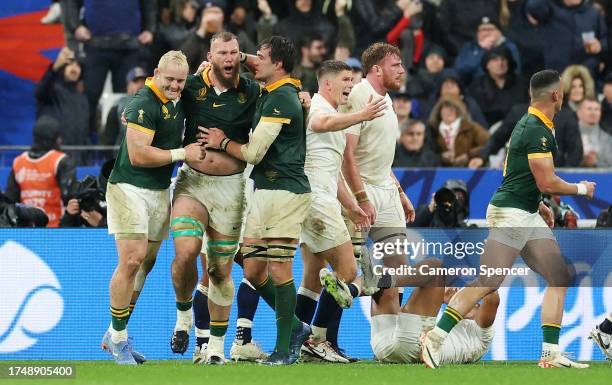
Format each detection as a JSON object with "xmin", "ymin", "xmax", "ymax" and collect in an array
[{"xmin": 13, "ymin": 150, "xmax": 66, "ymax": 227}]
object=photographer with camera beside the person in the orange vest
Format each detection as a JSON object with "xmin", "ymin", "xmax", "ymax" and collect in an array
[{"xmin": 60, "ymin": 159, "xmax": 115, "ymax": 227}]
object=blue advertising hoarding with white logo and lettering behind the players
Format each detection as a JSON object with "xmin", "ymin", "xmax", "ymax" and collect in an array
[{"xmin": 0, "ymin": 229, "xmax": 612, "ymax": 360}]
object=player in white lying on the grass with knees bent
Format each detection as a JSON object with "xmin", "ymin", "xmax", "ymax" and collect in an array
[{"xmin": 370, "ymin": 287, "xmax": 499, "ymax": 364}]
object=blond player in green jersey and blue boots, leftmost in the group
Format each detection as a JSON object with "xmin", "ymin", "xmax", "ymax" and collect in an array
[{"xmin": 102, "ymin": 51, "xmax": 204, "ymax": 365}]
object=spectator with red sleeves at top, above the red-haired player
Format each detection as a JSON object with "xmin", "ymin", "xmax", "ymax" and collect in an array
[{"xmin": 387, "ymin": 0, "xmax": 425, "ymax": 72}]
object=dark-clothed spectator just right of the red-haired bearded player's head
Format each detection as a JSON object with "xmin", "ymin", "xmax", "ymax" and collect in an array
[{"xmin": 406, "ymin": 45, "xmax": 447, "ymax": 99}]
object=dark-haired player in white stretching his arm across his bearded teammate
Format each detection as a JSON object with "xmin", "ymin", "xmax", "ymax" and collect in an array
[{"xmin": 296, "ymin": 60, "xmax": 386, "ymax": 362}]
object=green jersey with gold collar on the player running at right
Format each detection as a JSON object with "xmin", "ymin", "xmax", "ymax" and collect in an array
[{"xmin": 491, "ymin": 107, "xmax": 557, "ymax": 213}]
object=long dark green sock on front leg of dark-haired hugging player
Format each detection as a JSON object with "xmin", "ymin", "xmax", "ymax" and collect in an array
[{"xmin": 274, "ymin": 279, "xmax": 296, "ymax": 353}]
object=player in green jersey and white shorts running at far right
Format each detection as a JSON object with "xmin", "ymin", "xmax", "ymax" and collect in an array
[{"xmin": 421, "ymin": 70, "xmax": 595, "ymax": 368}]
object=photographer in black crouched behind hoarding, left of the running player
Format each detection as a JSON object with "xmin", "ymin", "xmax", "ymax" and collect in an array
[{"xmin": 408, "ymin": 179, "xmax": 470, "ymax": 228}]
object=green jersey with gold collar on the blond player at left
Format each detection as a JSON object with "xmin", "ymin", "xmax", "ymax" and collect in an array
[{"xmin": 109, "ymin": 78, "xmax": 185, "ymax": 190}]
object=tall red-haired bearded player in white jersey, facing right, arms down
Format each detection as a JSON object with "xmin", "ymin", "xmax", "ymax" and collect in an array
[{"xmin": 340, "ymin": 43, "xmax": 415, "ymax": 290}]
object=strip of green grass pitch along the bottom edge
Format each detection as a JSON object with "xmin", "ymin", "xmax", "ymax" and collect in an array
[{"xmin": 0, "ymin": 360, "xmax": 612, "ymax": 385}]
